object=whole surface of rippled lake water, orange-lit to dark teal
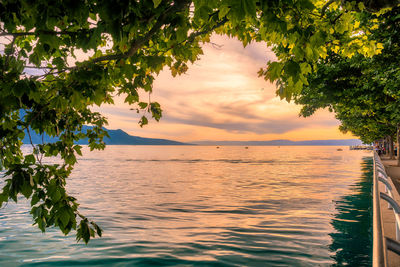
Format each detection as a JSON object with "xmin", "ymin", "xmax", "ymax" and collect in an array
[{"xmin": 0, "ymin": 146, "xmax": 372, "ymax": 266}]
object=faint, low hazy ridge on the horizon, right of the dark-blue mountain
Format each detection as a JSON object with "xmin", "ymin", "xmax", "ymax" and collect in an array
[{"xmin": 191, "ymin": 139, "xmax": 362, "ymax": 146}]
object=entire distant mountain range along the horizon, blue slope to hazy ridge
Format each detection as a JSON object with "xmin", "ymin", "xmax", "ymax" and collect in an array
[{"xmin": 23, "ymin": 126, "xmax": 362, "ymax": 146}]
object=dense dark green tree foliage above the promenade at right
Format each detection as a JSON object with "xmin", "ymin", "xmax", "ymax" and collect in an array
[{"xmin": 294, "ymin": 7, "xmax": 400, "ymax": 164}]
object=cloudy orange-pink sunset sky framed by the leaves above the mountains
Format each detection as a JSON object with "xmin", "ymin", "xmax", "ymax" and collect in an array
[{"xmin": 97, "ymin": 35, "xmax": 354, "ymax": 142}]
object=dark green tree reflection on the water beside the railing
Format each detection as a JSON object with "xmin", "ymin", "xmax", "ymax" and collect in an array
[{"xmin": 329, "ymin": 157, "xmax": 373, "ymax": 266}]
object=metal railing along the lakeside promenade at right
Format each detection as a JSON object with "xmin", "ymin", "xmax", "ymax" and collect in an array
[{"xmin": 372, "ymin": 152, "xmax": 400, "ymax": 267}]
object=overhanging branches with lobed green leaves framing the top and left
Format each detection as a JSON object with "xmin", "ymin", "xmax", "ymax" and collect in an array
[{"xmin": 0, "ymin": 0, "xmax": 395, "ymax": 242}]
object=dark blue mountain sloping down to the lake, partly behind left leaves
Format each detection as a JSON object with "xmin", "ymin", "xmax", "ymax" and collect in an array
[{"xmin": 22, "ymin": 126, "xmax": 190, "ymax": 146}]
